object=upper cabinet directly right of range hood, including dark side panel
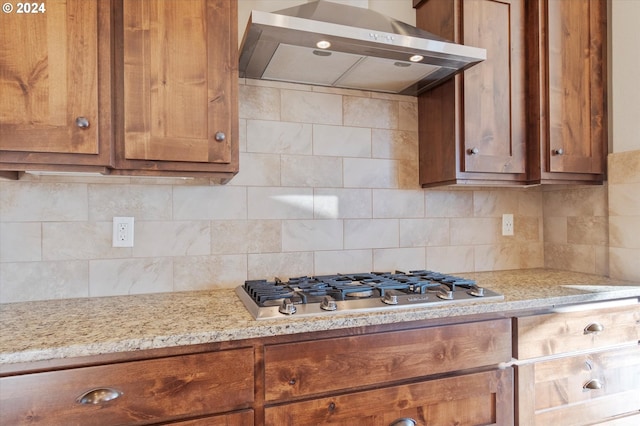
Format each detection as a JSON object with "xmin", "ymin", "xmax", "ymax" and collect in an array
[{"xmin": 416, "ymin": 0, "xmax": 527, "ymax": 187}]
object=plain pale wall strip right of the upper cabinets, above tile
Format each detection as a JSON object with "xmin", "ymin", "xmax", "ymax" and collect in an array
[{"xmin": 608, "ymin": 0, "xmax": 640, "ymax": 152}]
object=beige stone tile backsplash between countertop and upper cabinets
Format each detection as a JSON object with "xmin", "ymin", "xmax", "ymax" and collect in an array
[{"xmin": 5, "ymin": 81, "xmax": 640, "ymax": 303}]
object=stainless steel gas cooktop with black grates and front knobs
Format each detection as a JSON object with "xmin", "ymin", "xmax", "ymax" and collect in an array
[{"xmin": 236, "ymin": 270, "xmax": 504, "ymax": 319}]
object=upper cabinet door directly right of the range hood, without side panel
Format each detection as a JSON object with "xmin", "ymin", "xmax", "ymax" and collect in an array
[{"xmin": 462, "ymin": 0, "xmax": 527, "ymax": 173}]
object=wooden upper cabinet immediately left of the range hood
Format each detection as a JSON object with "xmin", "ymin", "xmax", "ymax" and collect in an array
[{"xmin": 116, "ymin": 0, "xmax": 238, "ymax": 174}]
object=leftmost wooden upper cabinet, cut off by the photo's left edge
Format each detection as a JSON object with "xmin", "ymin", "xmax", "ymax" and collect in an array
[{"xmin": 0, "ymin": 0, "xmax": 111, "ymax": 170}]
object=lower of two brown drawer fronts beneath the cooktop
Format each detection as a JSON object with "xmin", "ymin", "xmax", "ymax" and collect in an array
[{"xmin": 265, "ymin": 368, "xmax": 513, "ymax": 426}]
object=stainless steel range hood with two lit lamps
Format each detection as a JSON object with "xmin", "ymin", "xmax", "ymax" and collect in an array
[{"xmin": 240, "ymin": 0, "xmax": 486, "ymax": 96}]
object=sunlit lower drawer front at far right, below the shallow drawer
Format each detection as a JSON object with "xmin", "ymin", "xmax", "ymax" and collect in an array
[{"xmin": 518, "ymin": 346, "xmax": 640, "ymax": 426}]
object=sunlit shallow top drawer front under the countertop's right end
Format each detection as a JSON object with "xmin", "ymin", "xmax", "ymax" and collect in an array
[{"xmin": 514, "ymin": 304, "xmax": 640, "ymax": 359}]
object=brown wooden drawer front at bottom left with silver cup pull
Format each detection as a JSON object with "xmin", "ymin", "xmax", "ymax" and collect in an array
[{"xmin": 0, "ymin": 349, "xmax": 254, "ymax": 426}]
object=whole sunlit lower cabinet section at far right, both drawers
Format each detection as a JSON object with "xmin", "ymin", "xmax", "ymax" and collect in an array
[{"xmin": 514, "ymin": 299, "xmax": 640, "ymax": 426}]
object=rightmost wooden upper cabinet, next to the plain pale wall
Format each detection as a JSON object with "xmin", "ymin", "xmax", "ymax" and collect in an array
[{"xmin": 527, "ymin": 0, "xmax": 608, "ymax": 182}]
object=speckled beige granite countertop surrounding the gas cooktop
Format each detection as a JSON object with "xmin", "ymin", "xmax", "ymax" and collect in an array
[{"xmin": 0, "ymin": 269, "xmax": 640, "ymax": 364}]
